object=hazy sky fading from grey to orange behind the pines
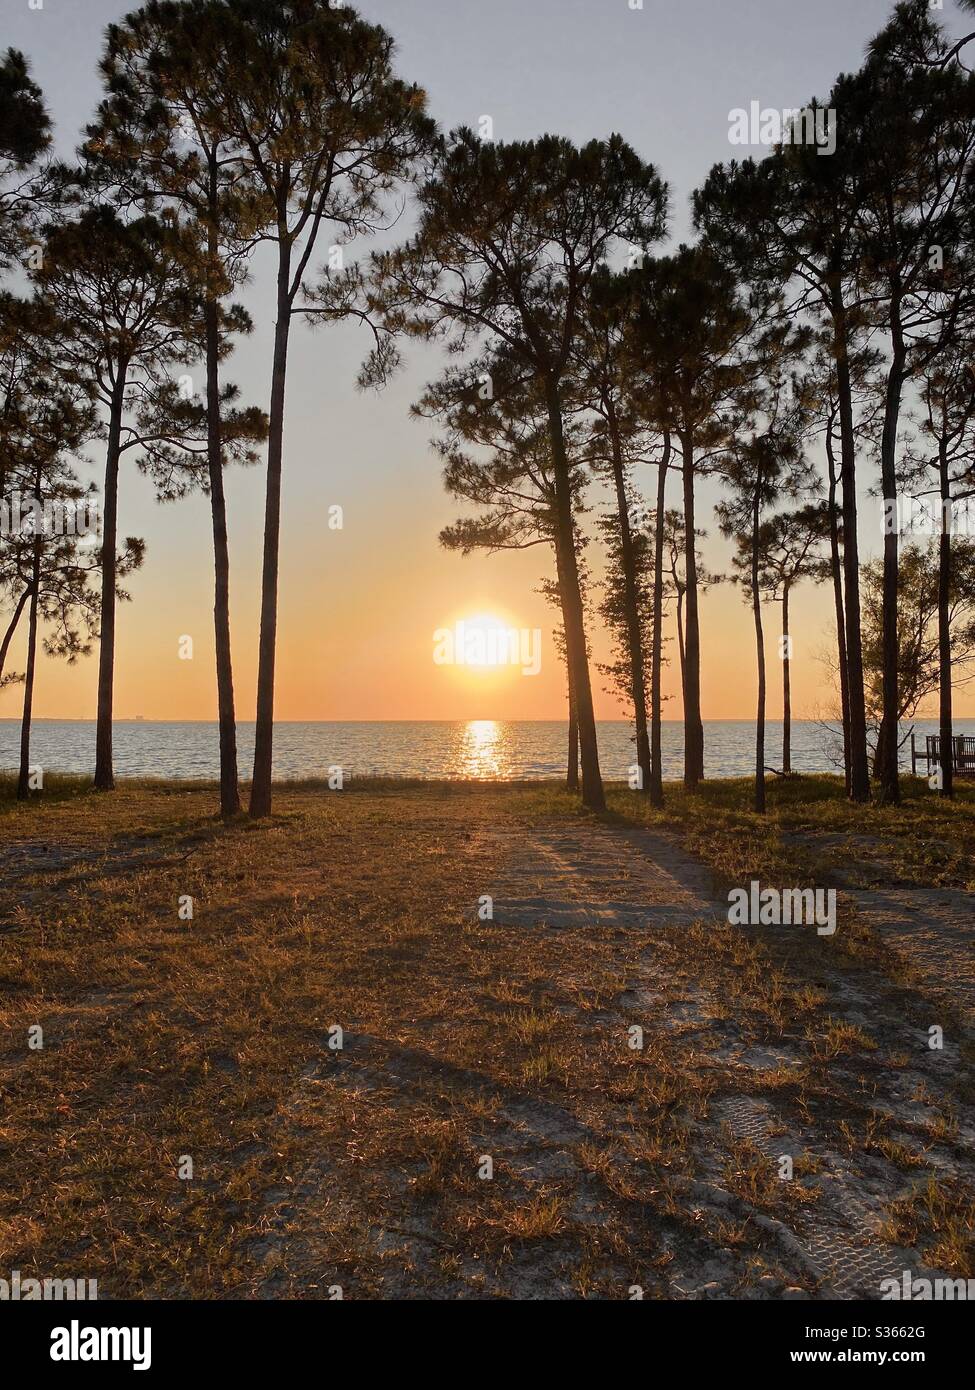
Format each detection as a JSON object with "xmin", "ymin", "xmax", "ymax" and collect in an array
[{"xmin": 0, "ymin": 0, "xmax": 975, "ymax": 720}]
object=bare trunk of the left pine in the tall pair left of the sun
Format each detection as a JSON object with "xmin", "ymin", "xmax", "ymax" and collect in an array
[{"xmin": 204, "ymin": 173, "xmax": 241, "ymax": 819}]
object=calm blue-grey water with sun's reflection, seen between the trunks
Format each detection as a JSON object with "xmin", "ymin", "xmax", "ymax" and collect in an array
[{"xmin": 0, "ymin": 720, "xmax": 975, "ymax": 780}]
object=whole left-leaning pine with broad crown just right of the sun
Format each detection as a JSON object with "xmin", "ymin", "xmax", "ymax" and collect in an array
[{"xmin": 370, "ymin": 131, "xmax": 662, "ymax": 810}]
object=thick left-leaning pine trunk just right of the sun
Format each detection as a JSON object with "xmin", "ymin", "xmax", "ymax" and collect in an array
[{"xmin": 548, "ymin": 384, "xmax": 606, "ymax": 810}]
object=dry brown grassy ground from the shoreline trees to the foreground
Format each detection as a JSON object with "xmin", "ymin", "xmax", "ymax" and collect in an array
[{"xmin": 0, "ymin": 778, "xmax": 975, "ymax": 1298}]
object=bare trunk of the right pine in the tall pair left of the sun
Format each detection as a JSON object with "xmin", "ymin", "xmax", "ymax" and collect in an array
[{"xmin": 250, "ymin": 250, "xmax": 291, "ymax": 817}]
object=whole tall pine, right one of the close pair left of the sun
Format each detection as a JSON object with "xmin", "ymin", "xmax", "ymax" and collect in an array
[{"xmin": 179, "ymin": 0, "xmax": 433, "ymax": 816}]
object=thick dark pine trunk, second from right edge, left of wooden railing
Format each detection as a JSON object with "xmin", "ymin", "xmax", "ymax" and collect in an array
[{"xmin": 876, "ymin": 328, "xmax": 905, "ymax": 805}]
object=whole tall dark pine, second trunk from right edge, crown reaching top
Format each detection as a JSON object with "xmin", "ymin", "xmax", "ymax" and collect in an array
[{"xmin": 837, "ymin": 0, "xmax": 975, "ymax": 802}]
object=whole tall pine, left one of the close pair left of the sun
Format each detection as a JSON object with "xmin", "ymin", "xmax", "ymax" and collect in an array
[{"xmin": 82, "ymin": 0, "xmax": 267, "ymax": 817}]
